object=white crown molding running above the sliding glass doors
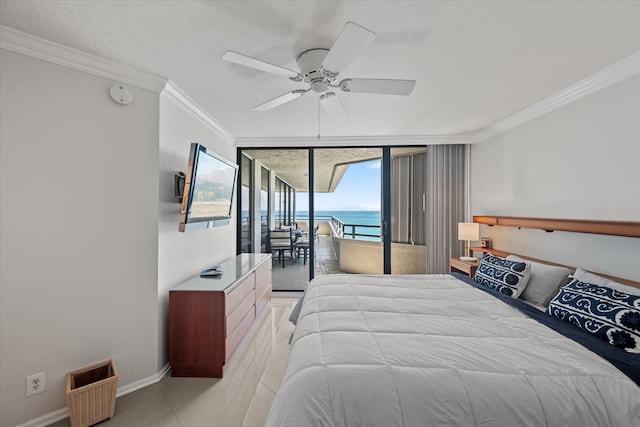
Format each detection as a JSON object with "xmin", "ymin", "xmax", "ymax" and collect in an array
[{"xmin": 236, "ymin": 133, "xmax": 475, "ymax": 148}]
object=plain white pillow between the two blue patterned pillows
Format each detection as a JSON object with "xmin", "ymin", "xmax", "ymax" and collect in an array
[{"xmin": 507, "ymin": 255, "xmax": 571, "ymax": 307}]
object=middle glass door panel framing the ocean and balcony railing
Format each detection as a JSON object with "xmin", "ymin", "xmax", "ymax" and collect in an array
[{"xmin": 313, "ymin": 147, "xmax": 384, "ymax": 276}]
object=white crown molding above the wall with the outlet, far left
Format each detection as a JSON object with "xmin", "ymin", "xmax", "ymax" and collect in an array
[{"xmin": 0, "ymin": 25, "xmax": 168, "ymax": 93}]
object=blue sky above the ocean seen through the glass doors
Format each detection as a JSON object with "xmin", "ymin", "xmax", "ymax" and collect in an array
[{"xmin": 296, "ymin": 159, "xmax": 381, "ymax": 211}]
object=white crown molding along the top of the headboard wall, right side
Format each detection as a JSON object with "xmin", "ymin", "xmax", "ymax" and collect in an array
[{"xmin": 476, "ymin": 52, "xmax": 640, "ymax": 142}]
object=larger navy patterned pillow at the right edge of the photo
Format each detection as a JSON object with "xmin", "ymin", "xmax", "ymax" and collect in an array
[{"xmin": 548, "ymin": 280, "xmax": 640, "ymax": 353}]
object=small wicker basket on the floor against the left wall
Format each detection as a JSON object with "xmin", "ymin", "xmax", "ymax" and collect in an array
[{"xmin": 67, "ymin": 360, "xmax": 118, "ymax": 427}]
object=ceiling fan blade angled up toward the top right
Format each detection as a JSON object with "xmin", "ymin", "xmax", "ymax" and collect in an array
[{"xmin": 322, "ymin": 22, "xmax": 376, "ymax": 74}]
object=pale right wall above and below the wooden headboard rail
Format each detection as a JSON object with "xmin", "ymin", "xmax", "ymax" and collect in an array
[{"xmin": 471, "ymin": 74, "xmax": 640, "ymax": 281}]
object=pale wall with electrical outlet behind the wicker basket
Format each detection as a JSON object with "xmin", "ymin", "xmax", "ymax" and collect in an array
[{"xmin": 0, "ymin": 50, "xmax": 160, "ymax": 426}]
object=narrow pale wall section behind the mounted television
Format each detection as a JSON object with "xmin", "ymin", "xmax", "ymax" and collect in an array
[{"xmin": 157, "ymin": 91, "xmax": 237, "ymax": 370}]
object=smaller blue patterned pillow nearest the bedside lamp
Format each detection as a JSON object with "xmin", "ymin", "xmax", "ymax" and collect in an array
[{"xmin": 473, "ymin": 254, "xmax": 531, "ymax": 298}]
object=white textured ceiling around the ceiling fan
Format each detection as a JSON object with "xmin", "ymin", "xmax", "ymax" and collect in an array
[{"xmin": 0, "ymin": 0, "xmax": 640, "ymax": 138}]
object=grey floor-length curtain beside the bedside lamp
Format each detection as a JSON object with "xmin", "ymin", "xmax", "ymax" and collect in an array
[{"xmin": 425, "ymin": 145, "xmax": 465, "ymax": 274}]
